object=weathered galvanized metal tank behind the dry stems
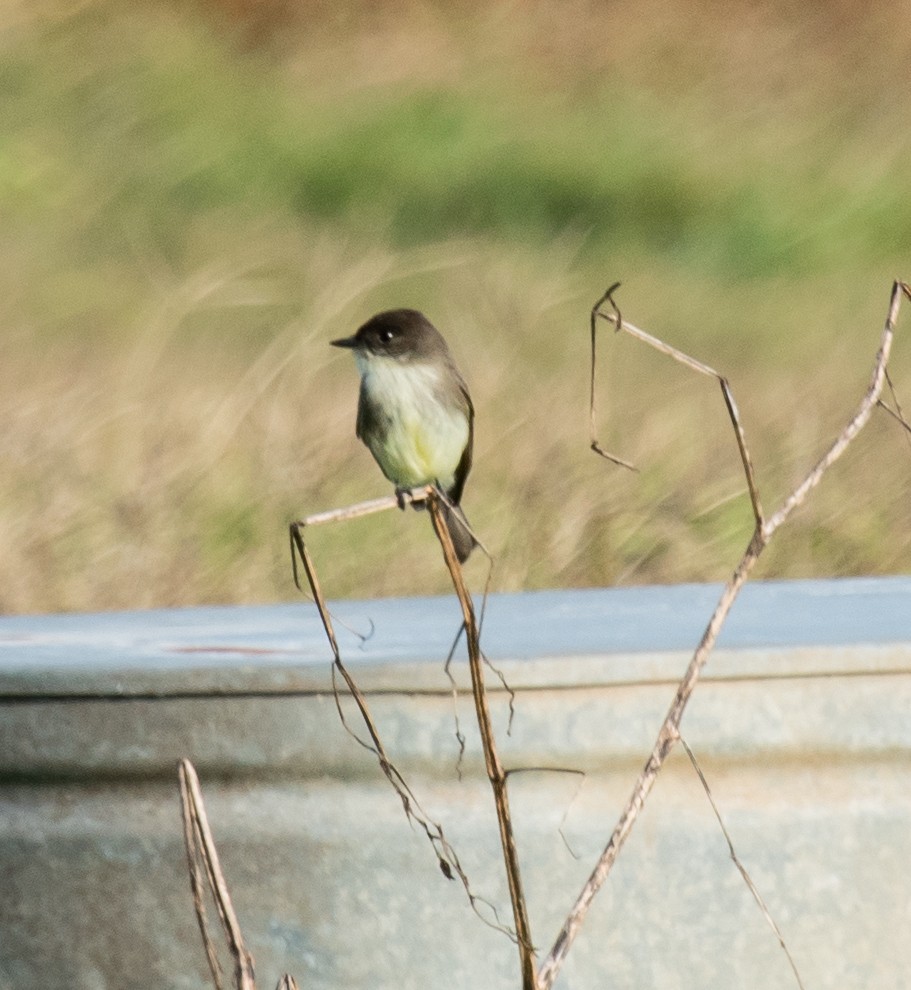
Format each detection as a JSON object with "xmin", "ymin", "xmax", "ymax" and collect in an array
[{"xmin": 0, "ymin": 578, "xmax": 911, "ymax": 990}]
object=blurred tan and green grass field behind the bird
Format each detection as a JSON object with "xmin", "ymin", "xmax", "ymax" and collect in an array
[{"xmin": 0, "ymin": 0, "xmax": 911, "ymax": 612}]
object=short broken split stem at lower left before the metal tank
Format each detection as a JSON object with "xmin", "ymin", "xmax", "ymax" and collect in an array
[{"xmin": 178, "ymin": 759, "xmax": 256, "ymax": 990}]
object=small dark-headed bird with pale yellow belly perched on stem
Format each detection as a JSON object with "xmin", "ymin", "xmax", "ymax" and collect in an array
[{"xmin": 332, "ymin": 309, "xmax": 475, "ymax": 563}]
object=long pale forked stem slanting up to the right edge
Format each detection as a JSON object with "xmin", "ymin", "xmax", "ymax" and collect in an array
[{"xmin": 538, "ymin": 282, "xmax": 911, "ymax": 990}]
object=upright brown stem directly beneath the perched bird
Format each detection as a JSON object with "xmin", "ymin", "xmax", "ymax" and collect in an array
[{"xmin": 427, "ymin": 491, "xmax": 538, "ymax": 990}]
